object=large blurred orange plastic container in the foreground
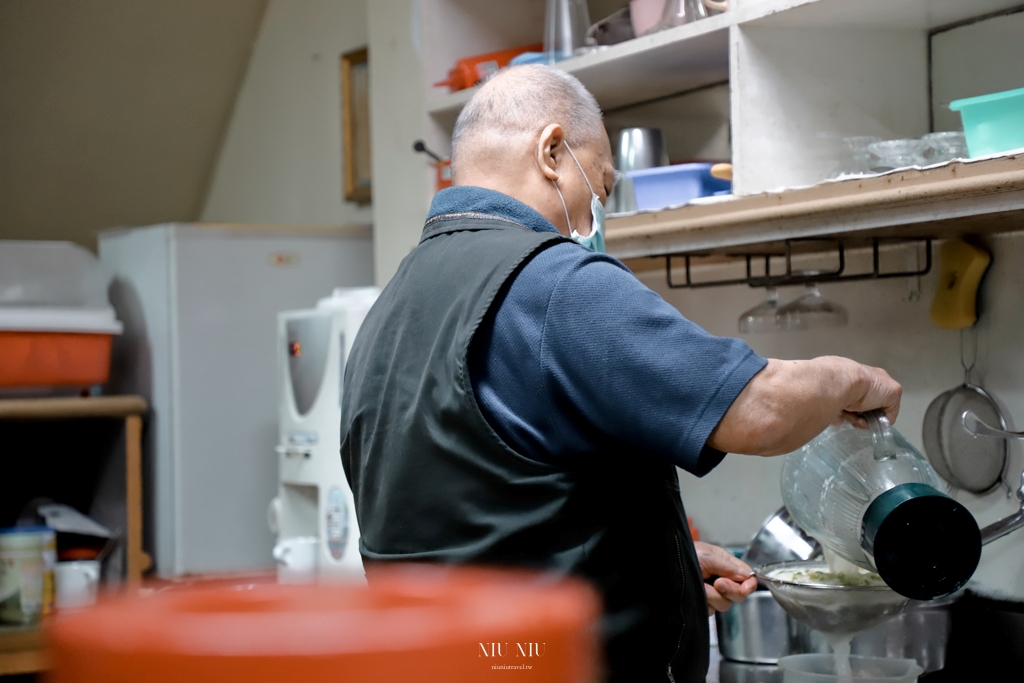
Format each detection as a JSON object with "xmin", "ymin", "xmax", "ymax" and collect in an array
[{"xmin": 48, "ymin": 566, "xmax": 599, "ymax": 683}]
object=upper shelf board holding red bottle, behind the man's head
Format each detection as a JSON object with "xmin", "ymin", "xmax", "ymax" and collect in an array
[{"xmin": 427, "ymin": 12, "xmax": 731, "ymax": 128}]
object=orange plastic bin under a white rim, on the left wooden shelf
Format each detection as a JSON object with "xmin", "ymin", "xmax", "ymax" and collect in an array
[{"xmin": 0, "ymin": 331, "xmax": 114, "ymax": 387}]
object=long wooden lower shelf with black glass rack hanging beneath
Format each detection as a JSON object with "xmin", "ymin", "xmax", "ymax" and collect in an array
[{"xmin": 606, "ymin": 154, "xmax": 1024, "ymax": 259}]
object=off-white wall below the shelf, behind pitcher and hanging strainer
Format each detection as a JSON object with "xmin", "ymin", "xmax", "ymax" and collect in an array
[{"xmin": 641, "ymin": 236, "xmax": 1024, "ymax": 597}]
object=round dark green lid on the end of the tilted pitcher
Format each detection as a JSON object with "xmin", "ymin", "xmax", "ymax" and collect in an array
[{"xmin": 861, "ymin": 483, "xmax": 981, "ymax": 600}]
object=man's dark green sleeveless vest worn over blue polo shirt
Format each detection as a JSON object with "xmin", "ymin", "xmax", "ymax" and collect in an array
[{"xmin": 341, "ymin": 214, "xmax": 709, "ymax": 683}]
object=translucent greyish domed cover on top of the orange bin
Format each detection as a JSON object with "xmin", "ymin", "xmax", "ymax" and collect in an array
[{"xmin": 0, "ymin": 240, "xmax": 110, "ymax": 308}]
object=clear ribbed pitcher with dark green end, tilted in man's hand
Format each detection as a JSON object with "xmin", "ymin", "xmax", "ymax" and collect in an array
[{"xmin": 782, "ymin": 414, "xmax": 981, "ymax": 599}]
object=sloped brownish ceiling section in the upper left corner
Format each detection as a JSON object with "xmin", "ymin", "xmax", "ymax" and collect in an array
[{"xmin": 0, "ymin": 0, "xmax": 266, "ymax": 247}]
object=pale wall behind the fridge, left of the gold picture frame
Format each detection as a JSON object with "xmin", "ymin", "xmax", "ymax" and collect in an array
[{"xmin": 202, "ymin": 0, "xmax": 372, "ymax": 224}]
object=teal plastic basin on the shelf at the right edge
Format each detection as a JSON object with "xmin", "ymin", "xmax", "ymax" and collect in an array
[{"xmin": 949, "ymin": 88, "xmax": 1024, "ymax": 158}]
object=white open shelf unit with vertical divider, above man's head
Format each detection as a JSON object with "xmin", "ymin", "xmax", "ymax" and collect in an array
[{"xmin": 427, "ymin": 0, "xmax": 1024, "ymax": 195}]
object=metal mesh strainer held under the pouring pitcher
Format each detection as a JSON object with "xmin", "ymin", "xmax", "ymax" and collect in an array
[{"xmin": 755, "ymin": 561, "xmax": 909, "ymax": 636}]
